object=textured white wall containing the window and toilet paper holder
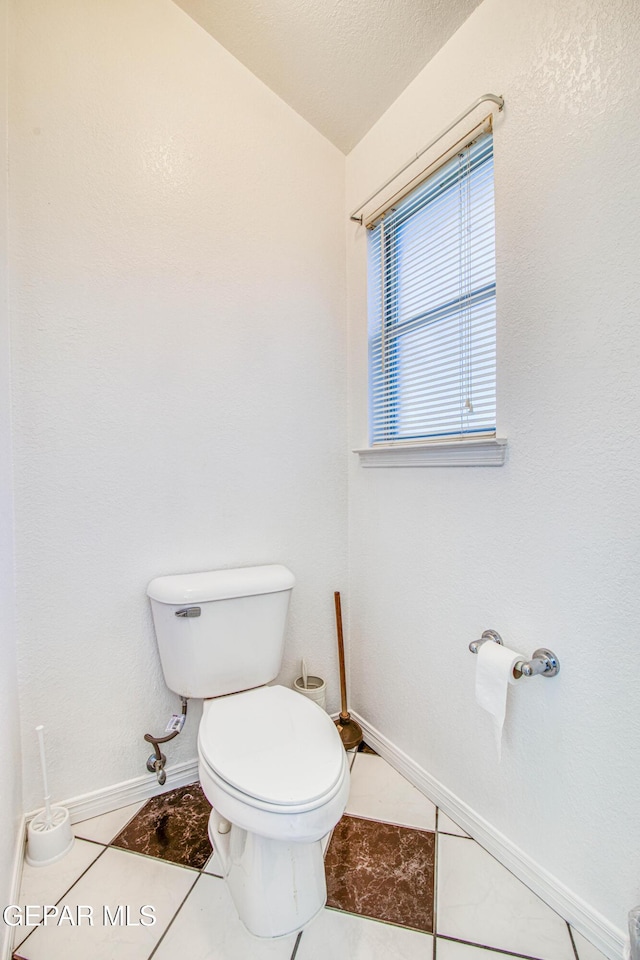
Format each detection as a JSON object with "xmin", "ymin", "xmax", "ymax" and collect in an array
[{"xmin": 347, "ymin": 0, "xmax": 640, "ymax": 928}]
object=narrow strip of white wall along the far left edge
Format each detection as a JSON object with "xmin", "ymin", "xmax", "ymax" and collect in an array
[{"xmin": 0, "ymin": 0, "xmax": 22, "ymax": 936}]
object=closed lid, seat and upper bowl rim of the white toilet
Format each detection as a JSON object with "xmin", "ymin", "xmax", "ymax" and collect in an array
[{"xmin": 198, "ymin": 686, "xmax": 349, "ymax": 841}]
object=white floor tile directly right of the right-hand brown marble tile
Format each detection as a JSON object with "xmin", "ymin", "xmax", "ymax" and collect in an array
[{"xmin": 437, "ymin": 833, "xmax": 573, "ymax": 960}]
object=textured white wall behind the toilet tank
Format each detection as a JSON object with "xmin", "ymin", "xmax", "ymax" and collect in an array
[{"xmin": 11, "ymin": 0, "xmax": 346, "ymax": 809}]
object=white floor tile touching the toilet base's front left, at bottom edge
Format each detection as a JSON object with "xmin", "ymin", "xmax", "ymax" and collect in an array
[{"xmin": 153, "ymin": 874, "xmax": 296, "ymax": 960}]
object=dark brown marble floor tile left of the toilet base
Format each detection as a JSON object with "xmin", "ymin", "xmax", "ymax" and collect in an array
[{"xmin": 111, "ymin": 783, "xmax": 213, "ymax": 870}]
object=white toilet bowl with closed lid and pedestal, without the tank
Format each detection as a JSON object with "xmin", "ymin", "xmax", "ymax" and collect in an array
[{"xmin": 198, "ymin": 686, "xmax": 349, "ymax": 937}]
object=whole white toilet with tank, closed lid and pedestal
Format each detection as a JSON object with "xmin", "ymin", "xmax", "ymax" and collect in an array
[{"xmin": 147, "ymin": 564, "xmax": 349, "ymax": 938}]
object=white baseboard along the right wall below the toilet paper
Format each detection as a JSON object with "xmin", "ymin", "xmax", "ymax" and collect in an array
[{"xmin": 351, "ymin": 710, "xmax": 625, "ymax": 960}]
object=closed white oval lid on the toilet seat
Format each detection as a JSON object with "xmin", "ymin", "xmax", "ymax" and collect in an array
[{"xmin": 198, "ymin": 686, "xmax": 343, "ymax": 806}]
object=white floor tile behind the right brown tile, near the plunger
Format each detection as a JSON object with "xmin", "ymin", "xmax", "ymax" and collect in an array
[{"xmin": 346, "ymin": 753, "xmax": 436, "ymax": 830}]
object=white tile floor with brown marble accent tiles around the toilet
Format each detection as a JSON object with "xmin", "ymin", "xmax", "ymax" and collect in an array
[{"xmin": 14, "ymin": 751, "xmax": 603, "ymax": 960}]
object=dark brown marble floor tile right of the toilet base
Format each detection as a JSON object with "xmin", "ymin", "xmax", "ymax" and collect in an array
[{"xmin": 325, "ymin": 816, "xmax": 435, "ymax": 933}]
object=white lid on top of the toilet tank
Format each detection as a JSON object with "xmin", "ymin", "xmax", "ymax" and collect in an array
[{"xmin": 147, "ymin": 563, "xmax": 296, "ymax": 604}]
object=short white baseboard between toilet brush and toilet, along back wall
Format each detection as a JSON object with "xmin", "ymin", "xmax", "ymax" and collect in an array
[{"xmin": 25, "ymin": 760, "xmax": 198, "ymax": 823}]
